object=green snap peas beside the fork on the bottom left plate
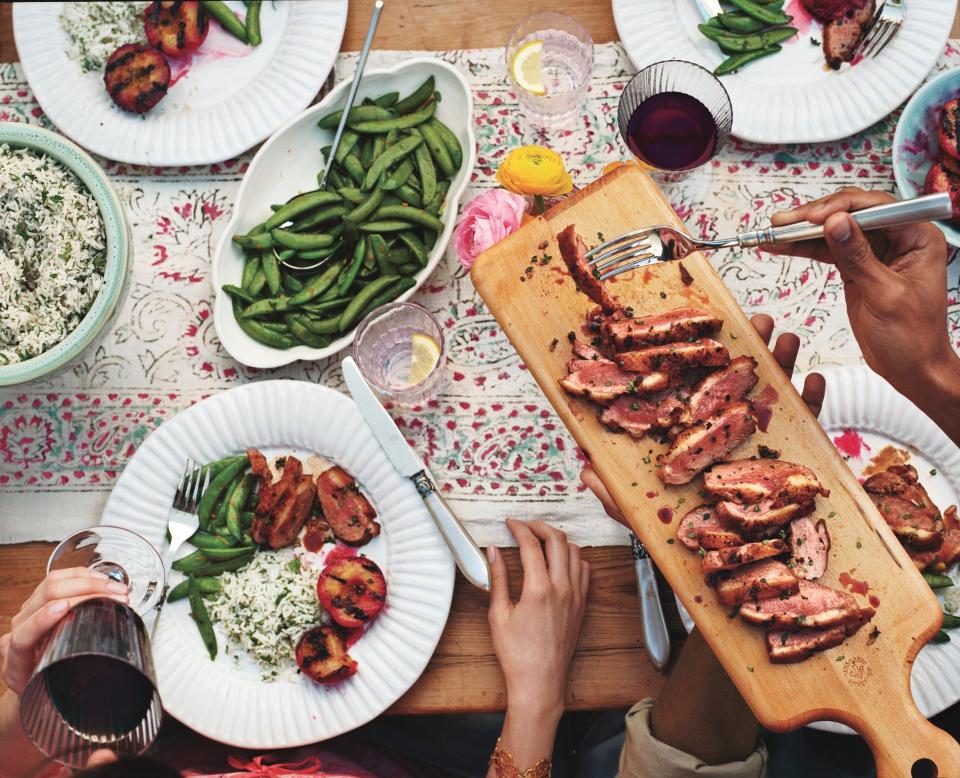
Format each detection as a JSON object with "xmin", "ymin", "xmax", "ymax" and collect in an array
[{"xmin": 167, "ymin": 454, "xmax": 259, "ymax": 659}]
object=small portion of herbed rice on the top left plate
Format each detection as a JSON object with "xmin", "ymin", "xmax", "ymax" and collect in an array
[{"xmin": 60, "ymin": 2, "xmax": 148, "ymax": 73}]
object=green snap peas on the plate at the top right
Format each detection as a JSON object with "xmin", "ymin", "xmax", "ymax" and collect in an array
[{"xmin": 698, "ymin": 0, "xmax": 797, "ymax": 76}]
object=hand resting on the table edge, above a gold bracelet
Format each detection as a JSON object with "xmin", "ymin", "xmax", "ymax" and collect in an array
[{"xmin": 487, "ymin": 519, "xmax": 590, "ymax": 720}]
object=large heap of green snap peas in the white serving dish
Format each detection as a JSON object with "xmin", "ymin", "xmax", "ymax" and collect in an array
[{"xmin": 223, "ymin": 76, "xmax": 463, "ymax": 349}]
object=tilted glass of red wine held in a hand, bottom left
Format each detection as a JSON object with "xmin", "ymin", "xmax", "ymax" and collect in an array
[{"xmin": 20, "ymin": 526, "xmax": 165, "ymax": 768}]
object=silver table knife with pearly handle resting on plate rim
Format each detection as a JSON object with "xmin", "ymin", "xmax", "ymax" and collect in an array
[{"xmin": 340, "ymin": 357, "xmax": 490, "ymax": 591}]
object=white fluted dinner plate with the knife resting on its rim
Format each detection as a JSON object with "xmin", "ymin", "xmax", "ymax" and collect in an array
[{"xmin": 102, "ymin": 381, "xmax": 454, "ymax": 749}]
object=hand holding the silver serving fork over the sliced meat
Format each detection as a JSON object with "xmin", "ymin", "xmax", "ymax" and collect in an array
[{"xmin": 769, "ymin": 188, "xmax": 960, "ymax": 404}]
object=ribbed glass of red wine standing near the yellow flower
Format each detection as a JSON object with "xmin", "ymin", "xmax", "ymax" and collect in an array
[{"xmin": 617, "ymin": 59, "xmax": 733, "ymax": 181}]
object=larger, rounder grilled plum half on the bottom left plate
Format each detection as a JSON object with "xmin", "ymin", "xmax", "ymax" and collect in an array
[{"xmin": 317, "ymin": 556, "xmax": 387, "ymax": 629}]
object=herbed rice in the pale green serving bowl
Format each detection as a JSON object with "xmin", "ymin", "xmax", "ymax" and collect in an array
[{"xmin": 0, "ymin": 144, "xmax": 106, "ymax": 365}]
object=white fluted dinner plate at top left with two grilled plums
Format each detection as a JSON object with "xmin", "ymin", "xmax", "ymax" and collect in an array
[{"xmin": 13, "ymin": 0, "xmax": 347, "ymax": 165}]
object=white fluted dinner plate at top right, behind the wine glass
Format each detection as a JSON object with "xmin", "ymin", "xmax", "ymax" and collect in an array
[{"xmin": 613, "ymin": 0, "xmax": 957, "ymax": 143}]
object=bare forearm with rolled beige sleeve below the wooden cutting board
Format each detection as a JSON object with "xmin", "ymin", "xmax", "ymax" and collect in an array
[{"xmin": 650, "ymin": 630, "xmax": 758, "ymax": 764}]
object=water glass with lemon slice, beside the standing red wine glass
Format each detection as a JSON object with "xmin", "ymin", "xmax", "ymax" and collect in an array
[{"xmin": 507, "ymin": 11, "xmax": 593, "ymax": 126}]
